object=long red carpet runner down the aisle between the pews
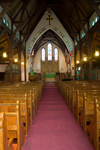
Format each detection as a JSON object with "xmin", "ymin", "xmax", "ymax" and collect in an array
[{"xmin": 23, "ymin": 87, "xmax": 93, "ymax": 150}]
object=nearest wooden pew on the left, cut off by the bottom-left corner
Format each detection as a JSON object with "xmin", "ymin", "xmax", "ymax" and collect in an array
[{"xmin": 0, "ymin": 113, "xmax": 14, "ymax": 150}]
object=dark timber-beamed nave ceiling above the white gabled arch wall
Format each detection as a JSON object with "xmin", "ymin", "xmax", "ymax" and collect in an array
[{"xmin": 1, "ymin": 0, "xmax": 100, "ymax": 39}]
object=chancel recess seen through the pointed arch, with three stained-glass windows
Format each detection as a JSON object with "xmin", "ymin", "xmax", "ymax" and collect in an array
[{"xmin": 28, "ymin": 30, "xmax": 68, "ymax": 81}]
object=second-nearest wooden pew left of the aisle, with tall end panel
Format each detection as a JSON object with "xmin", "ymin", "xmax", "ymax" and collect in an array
[{"xmin": 0, "ymin": 101, "xmax": 25, "ymax": 150}]
